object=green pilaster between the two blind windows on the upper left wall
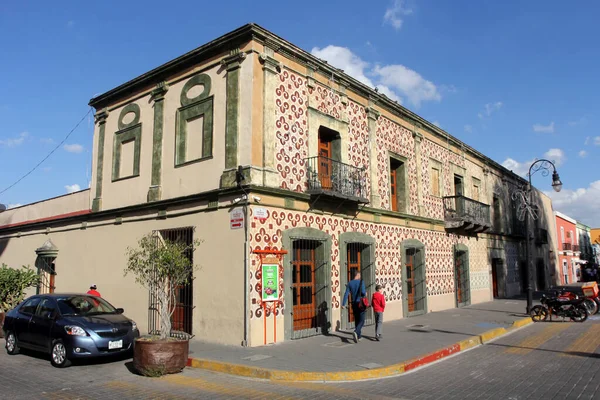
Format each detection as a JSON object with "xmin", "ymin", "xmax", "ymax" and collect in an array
[{"xmin": 148, "ymin": 82, "xmax": 169, "ymax": 202}]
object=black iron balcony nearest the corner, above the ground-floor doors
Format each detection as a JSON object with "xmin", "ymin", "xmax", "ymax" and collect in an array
[{"xmin": 306, "ymin": 156, "xmax": 369, "ymax": 204}]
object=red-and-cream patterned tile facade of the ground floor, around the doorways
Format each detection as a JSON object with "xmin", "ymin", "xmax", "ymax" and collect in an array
[{"xmin": 249, "ymin": 207, "xmax": 489, "ymax": 317}]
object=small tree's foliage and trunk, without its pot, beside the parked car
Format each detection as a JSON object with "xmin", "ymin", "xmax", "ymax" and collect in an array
[{"xmin": 124, "ymin": 233, "xmax": 201, "ymax": 339}]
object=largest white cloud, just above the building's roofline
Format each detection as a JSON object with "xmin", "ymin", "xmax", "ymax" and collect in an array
[{"xmin": 311, "ymin": 45, "xmax": 442, "ymax": 107}]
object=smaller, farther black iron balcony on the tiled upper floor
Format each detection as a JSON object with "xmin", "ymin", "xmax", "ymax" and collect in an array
[{"xmin": 444, "ymin": 196, "xmax": 492, "ymax": 234}]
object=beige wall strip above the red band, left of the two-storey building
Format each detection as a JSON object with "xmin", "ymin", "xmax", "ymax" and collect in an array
[{"xmin": 0, "ymin": 189, "xmax": 90, "ymax": 229}]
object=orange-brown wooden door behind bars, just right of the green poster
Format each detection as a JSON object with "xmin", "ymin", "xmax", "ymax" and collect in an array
[{"xmin": 292, "ymin": 244, "xmax": 317, "ymax": 331}]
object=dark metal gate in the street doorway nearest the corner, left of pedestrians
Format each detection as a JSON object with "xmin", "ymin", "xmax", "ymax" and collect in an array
[{"xmin": 291, "ymin": 239, "xmax": 330, "ymax": 339}]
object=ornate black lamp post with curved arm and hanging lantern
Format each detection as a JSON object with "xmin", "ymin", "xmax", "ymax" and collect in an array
[{"xmin": 512, "ymin": 159, "xmax": 562, "ymax": 314}]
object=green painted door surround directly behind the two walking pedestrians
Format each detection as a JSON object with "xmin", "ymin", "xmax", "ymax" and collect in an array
[{"xmin": 339, "ymin": 232, "xmax": 377, "ymax": 329}]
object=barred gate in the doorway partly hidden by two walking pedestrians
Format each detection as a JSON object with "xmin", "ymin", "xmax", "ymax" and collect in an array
[{"xmin": 344, "ymin": 243, "xmax": 375, "ymax": 329}]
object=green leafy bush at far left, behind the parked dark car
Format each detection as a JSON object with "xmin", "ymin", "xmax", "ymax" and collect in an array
[{"xmin": 0, "ymin": 264, "xmax": 39, "ymax": 337}]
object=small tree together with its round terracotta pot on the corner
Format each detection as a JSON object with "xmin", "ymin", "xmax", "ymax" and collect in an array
[{"xmin": 124, "ymin": 234, "xmax": 200, "ymax": 376}]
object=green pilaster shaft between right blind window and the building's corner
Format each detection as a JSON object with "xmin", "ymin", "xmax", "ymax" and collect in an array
[{"xmin": 225, "ymin": 68, "xmax": 240, "ymax": 168}]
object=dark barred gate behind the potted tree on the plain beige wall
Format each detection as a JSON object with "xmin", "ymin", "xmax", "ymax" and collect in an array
[{"xmin": 148, "ymin": 227, "xmax": 194, "ymax": 338}]
